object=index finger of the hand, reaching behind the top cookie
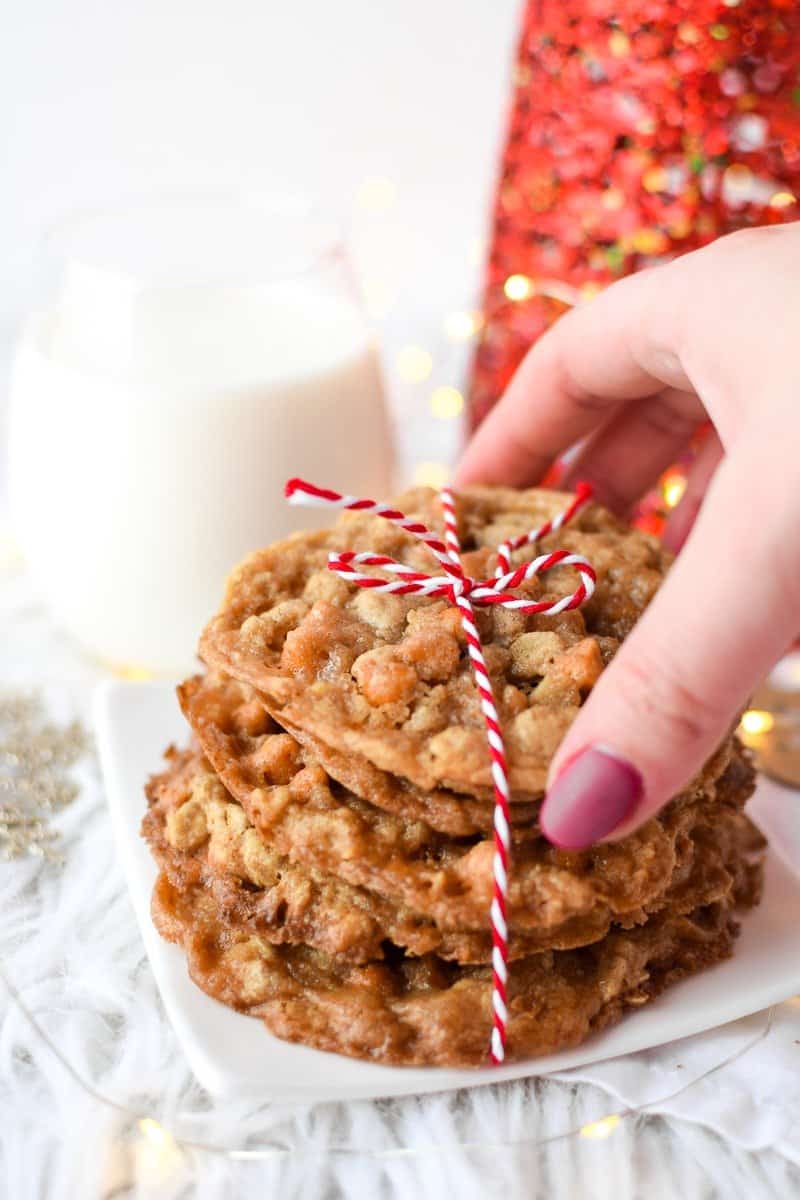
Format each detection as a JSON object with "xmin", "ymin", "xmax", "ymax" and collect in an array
[{"xmin": 455, "ymin": 264, "xmax": 691, "ymax": 487}]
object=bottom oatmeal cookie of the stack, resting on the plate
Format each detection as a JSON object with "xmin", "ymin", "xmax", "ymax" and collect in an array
[{"xmin": 152, "ymin": 835, "xmax": 758, "ymax": 1066}]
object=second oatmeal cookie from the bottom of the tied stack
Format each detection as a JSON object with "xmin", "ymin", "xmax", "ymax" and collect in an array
[{"xmin": 143, "ymin": 750, "xmax": 762, "ymax": 964}]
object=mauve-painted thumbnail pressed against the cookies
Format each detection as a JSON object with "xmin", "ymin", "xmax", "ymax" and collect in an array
[{"xmin": 540, "ymin": 745, "xmax": 644, "ymax": 850}]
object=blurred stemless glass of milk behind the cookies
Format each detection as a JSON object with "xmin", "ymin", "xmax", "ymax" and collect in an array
[{"xmin": 10, "ymin": 199, "xmax": 393, "ymax": 674}]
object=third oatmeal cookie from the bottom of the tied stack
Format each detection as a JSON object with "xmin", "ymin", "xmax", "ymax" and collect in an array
[{"xmin": 172, "ymin": 678, "xmax": 752, "ymax": 932}]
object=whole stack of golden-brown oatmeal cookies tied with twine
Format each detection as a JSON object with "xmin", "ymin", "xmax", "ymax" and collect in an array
[{"xmin": 144, "ymin": 488, "xmax": 762, "ymax": 1064}]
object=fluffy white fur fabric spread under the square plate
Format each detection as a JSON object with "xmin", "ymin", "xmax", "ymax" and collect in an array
[{"xmin": 0, "ymin": 561, "xmax": 800, "ymax": 1200}]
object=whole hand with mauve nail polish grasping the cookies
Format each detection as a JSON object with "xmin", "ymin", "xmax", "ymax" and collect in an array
[{"xmin": 456, "ymin": 223, "xmax": 800, "ymax": 848}]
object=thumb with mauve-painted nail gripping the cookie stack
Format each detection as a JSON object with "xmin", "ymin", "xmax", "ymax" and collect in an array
[{"xmin": 540, "ymin": 443, "xmax": 800, "ymax": 850}]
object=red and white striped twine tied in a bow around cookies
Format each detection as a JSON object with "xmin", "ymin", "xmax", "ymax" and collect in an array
[{"xmin": 285, "ymin": 479, "xmax": 595, "ymax": 1063}]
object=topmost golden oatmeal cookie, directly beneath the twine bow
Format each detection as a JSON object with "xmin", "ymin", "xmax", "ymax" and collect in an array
[{"xmin": 201, "ymin": 487, "xmax": 734, "ymax": 803}]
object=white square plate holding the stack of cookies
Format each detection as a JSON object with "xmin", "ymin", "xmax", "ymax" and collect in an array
[{"xmin": 96, "ymin": 683, "xmax": 800, "ymax": 1102}]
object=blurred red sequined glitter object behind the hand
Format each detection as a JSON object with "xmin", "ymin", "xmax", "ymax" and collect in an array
[{"xmin": 470, "ymin": 0, "xmax": 800, "ymax": 426}]
